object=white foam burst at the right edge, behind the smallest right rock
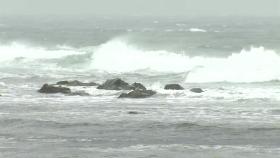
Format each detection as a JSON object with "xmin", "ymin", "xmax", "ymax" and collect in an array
[{"xmin": 186, "ymin": 47, "xmax": 280, "ymax": 82}]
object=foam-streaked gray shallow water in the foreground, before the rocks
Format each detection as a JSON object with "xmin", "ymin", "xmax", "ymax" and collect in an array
[{"xmin": 0, "ymin": 80, "xmax": 280, "ymax": 157}]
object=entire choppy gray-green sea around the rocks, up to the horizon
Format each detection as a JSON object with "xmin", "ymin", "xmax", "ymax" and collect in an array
[{"xmin": 0, "ymin": 17, "xmax": 280, "ymax": 158}]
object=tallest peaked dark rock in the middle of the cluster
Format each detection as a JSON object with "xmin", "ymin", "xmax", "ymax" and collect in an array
[{"xmin": 97, "ymin": 78, "xmax": 133, "ymax": 90}]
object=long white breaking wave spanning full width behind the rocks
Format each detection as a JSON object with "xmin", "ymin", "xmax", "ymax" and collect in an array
[{"xmin": 0, "ymin": 40, "xmax": 280, "ymax": 83}]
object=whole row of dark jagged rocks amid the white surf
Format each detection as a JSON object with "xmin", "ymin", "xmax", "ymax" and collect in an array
[{"xmin": 39, "ymin": 78, "xmax": 204, "ymax": 98}]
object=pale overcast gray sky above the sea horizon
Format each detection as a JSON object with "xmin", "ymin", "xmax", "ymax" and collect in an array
[{"xmin": 0, "ymin": 0, "xmax": 280, "ymax": 16}]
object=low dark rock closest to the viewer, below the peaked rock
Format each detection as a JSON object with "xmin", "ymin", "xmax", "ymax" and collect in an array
[{"xmin": 119, "ymin": 90, "xmax": 156, "ymax": 98}]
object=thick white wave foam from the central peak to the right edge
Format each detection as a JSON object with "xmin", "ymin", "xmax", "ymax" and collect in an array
[{"xmin": 91, "ymin": 40, "xmax": 280, "ymax": 82}]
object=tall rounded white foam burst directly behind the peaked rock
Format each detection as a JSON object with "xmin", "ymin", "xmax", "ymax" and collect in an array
[{"xmin": 91, "ymin": 40, "xmax": 188, "ymax": 73}]
